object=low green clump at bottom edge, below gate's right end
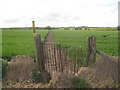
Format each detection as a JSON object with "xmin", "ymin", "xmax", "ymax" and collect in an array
[{"xmin": 72, "ymin": 77, "xmax": 91, "ymax": 88}]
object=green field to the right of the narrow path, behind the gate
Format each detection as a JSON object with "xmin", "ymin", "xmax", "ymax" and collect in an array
[{"xmin": 52, "ymin": 30, "xmax": 118, "ymax": 56}]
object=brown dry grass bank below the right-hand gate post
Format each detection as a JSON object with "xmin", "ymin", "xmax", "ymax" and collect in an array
[{"xmin": 78, "ymin": 55, "xmax": 118, "ymax": 88}]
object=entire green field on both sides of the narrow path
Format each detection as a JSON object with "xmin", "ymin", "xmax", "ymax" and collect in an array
[{"xmin": 2, "ymin": 29, "xmax": 118, "ymax": 58}]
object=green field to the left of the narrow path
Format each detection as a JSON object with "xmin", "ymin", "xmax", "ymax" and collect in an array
[{"xmin": 2, "ymin": 29, "xmax": 48, "ymax": 58}]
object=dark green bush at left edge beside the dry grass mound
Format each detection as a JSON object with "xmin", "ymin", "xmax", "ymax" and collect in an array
[{"xmin": 0, "ymin": 59, "xmax": 8, "ymax": 78}]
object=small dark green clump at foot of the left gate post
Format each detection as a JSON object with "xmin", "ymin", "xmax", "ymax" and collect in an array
[{"xmin": 32, "ymin": 70, "xmax": 42, "ymax": 83}]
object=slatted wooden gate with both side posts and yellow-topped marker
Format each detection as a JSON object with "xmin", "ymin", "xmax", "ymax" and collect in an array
[{"xmin": 33, "ymin": 21, "xmax": 96, "ymax": 75}]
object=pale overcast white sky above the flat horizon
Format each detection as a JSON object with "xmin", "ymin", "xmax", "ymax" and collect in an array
[{"xmin": 0, "ymin": 0, "xmax": 119, "ymax": 27}]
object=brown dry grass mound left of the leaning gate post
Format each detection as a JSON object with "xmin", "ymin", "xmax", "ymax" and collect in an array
[{"xmin": 5, "ymin": 55, "xmax": 37, "ymax": 82}]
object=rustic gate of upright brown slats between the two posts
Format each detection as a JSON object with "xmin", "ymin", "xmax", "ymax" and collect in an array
[{"xmin": 42, "ymin": 42, "xmax": 83, "ymax": 75}]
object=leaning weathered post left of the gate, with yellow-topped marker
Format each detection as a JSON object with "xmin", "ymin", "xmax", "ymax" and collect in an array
[{"xmin": 32, "ymin": 21, "xmax": 51, "ymax": 83}]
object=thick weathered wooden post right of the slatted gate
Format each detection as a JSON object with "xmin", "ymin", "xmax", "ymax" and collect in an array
[{"xmin": 86, "ymin": 37, "xmax": 96, "ymax": 65}]
